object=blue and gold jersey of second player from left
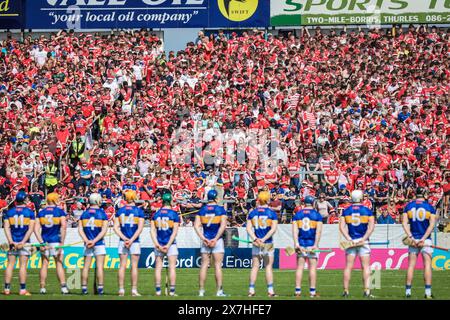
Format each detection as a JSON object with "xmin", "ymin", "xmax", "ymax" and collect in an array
[{"xmin": 37, "ymin": 206, "xmax": 66, "ymax": 243}]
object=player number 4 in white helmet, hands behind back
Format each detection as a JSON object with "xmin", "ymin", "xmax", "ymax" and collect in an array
[{"xmin": 78, "ymin": 193, "xmax": 108, "ymax": 295}]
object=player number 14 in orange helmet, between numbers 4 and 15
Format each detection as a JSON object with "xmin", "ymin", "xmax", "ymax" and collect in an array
[{"xmin": 114, "ymin": 189, "xmax": 145, "ymax": 297}]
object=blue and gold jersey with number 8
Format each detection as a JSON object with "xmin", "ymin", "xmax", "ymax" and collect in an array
[{"xmin": 292, "ymin": 208, "xmax": 322, "ymax": 247}]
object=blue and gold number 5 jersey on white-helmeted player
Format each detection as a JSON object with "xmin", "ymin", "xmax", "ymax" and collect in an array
[{"xmin": 342, "ymin": 204, "xmax": 374, "ymax": 240}]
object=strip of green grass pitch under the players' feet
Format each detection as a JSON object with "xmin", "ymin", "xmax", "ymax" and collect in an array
[{"xmin": 0, "ymin": 269, "xmax": 450, "ymax": 300}]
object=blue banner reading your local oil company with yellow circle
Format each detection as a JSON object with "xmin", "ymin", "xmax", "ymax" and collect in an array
[{"xmin": 26, "ymin": 0, "xmax": 270, "ymax": 30}]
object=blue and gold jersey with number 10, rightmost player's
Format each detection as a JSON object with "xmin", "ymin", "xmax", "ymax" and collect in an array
[{"xmin": 404, "ymin": 200, "xmax": 436, "ymax": 240}]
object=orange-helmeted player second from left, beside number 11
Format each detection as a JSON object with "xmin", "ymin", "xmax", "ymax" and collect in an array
[{"xmin": 34, "ymin": 192, "xmax": 69, "ymax": 294}]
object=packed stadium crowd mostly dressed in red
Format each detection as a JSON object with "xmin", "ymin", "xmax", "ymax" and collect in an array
[{"xmin": 0, "ymin": 26, "xmax": 450, "ymax": 226}]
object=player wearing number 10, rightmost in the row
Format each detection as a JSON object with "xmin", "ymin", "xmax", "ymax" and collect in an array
[{"xmin": 402, "ymin": 188, "xmax": 436, "ymax": 299}]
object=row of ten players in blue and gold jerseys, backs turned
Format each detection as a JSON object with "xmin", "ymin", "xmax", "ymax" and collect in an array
[{"xmin": 0, "ymin": 188, "xmax": 435, "ymax": 299}]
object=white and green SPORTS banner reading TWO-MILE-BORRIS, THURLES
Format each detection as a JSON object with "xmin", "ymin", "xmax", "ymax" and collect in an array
[{"xmin": 270, "ymin": 0, "xmax": 450, "ymax": 26}]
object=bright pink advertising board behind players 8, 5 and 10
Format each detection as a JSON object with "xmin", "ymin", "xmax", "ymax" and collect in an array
[{"xmin": 280, "ymin": 249, "xmax": 423, "ymax": 270}]
